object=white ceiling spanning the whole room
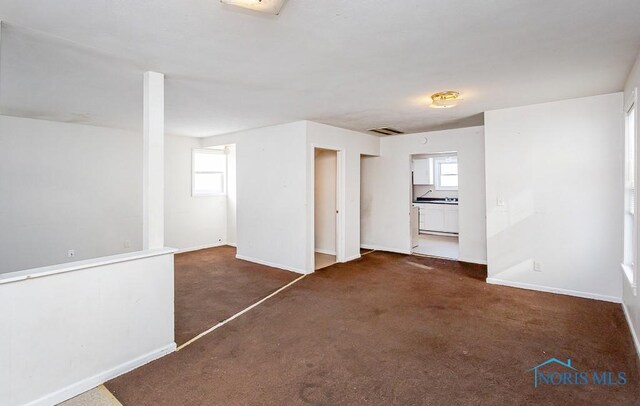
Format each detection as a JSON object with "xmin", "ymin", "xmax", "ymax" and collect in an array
[{"xmin": 0, "ymin": 0, "xmax": 640, "ymax": 136}]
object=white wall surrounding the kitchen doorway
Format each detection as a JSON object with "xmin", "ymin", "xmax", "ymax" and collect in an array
[{"xmin": 362, "ymin": 127, "xmax": 486, "ymax": 263}]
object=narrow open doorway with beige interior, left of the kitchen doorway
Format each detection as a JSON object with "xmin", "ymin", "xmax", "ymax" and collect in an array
[{"xmin": 314, "ymin": 148, "xmax": 338, "ymax": 270}]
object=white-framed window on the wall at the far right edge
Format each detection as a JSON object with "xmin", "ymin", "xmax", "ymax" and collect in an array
[{"xmin": 622, "ymin": 89, "xmax": 638, "ymax": 295}]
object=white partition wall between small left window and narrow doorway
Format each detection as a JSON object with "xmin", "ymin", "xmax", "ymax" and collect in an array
[{"xmin": 203, "ymin": 121, "xmax": 308, "ymax": 273}]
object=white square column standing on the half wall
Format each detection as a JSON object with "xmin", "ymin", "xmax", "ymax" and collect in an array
[{"xmin": 142, "ymin": 72, "xmax": 164, "ymax": 250}]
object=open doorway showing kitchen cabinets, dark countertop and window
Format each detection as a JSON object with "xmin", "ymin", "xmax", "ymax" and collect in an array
[{"xmin": 411, "ymin": 152, "xmax": 459, "ymax": 260}]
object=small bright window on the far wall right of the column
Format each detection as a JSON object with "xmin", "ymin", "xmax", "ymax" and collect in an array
[{"xmin": 191, "ymin": 149, "xmax": 227, "ymax": 197}]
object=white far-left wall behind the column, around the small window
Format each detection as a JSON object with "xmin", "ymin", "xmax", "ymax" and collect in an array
[{"xmin": 0, "ymin": 116, "xmax": 227, "ymax": 264}]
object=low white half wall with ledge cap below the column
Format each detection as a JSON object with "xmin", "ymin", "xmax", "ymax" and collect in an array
[{"xmin": 0, "ymin": 250, "xmax": 175, "ymax": 405}]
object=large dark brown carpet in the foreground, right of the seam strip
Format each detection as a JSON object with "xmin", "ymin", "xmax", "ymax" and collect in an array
[{"xmin": 107, "ymin": 252, "xmax": 640, "ymax": 405}]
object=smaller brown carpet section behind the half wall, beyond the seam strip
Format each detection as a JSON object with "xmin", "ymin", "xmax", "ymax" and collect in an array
[{"xmin": 175, "ymin": 246, "xmax": 300, "ymax": 345}]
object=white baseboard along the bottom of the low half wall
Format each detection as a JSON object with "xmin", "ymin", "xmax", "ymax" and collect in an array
[{"xmin": 27, "ymin": 343, "xmax": 176, "ymax": 406}]
